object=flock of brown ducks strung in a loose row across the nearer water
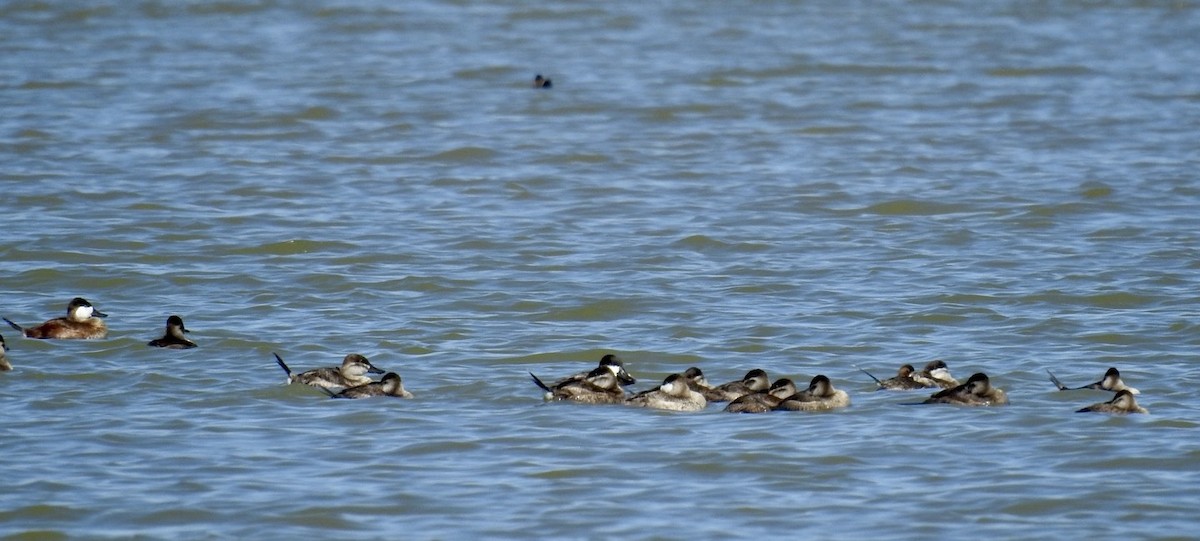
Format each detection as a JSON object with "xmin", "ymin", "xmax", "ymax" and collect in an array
[{"xmin": 0, "ymin": 297, "xmax": 1148, "ymax": 414}]
